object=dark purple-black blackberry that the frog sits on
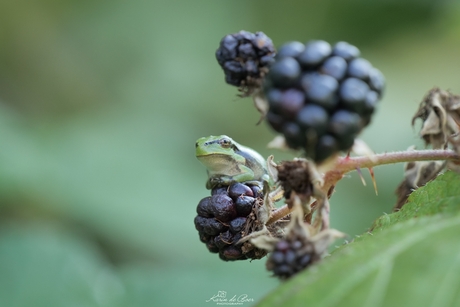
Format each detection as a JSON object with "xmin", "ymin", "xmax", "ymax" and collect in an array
[{"xmin": 195, "ymin": 183, "xmax": 266, "ymax": 261}]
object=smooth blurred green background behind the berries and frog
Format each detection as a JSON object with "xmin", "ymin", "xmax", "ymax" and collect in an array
[{"xmin": 0, "ymin": 0, "xmax": 460, "ymax": 307}]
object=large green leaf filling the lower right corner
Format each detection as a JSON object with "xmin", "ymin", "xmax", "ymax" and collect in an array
[{"xmin": 257, "ymin": 173, "xmax": 460, "ymax": 307}]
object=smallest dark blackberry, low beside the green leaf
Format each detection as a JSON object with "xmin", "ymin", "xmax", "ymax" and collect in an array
[{"xmin": 266, "ymin": 234, "xmax": 321, "ymax": 279}]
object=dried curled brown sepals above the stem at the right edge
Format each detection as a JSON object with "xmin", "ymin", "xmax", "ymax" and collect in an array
[{"xmin": 412, "ymin": 88, "xmax": 460, "ymax": 149}]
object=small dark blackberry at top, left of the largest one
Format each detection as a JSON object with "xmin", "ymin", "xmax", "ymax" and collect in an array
[{"xmin": 216, "ymin": 31, "xmax": 275, "ymax": 94}]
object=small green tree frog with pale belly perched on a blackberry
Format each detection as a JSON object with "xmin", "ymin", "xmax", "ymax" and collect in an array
[{"xmin": 195, "ymin": 135, "xmax": 270, "ymax": 189}]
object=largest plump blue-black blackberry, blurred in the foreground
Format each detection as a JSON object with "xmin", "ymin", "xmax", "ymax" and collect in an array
[{"xmin": 264, "ymin": 40, "xmax": 385, "ymax": 162}]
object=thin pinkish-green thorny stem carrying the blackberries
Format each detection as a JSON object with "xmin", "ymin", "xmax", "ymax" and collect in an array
[{"xmin": 267, "ymin": 149, "xmax": 460, "ymax": 225}]
